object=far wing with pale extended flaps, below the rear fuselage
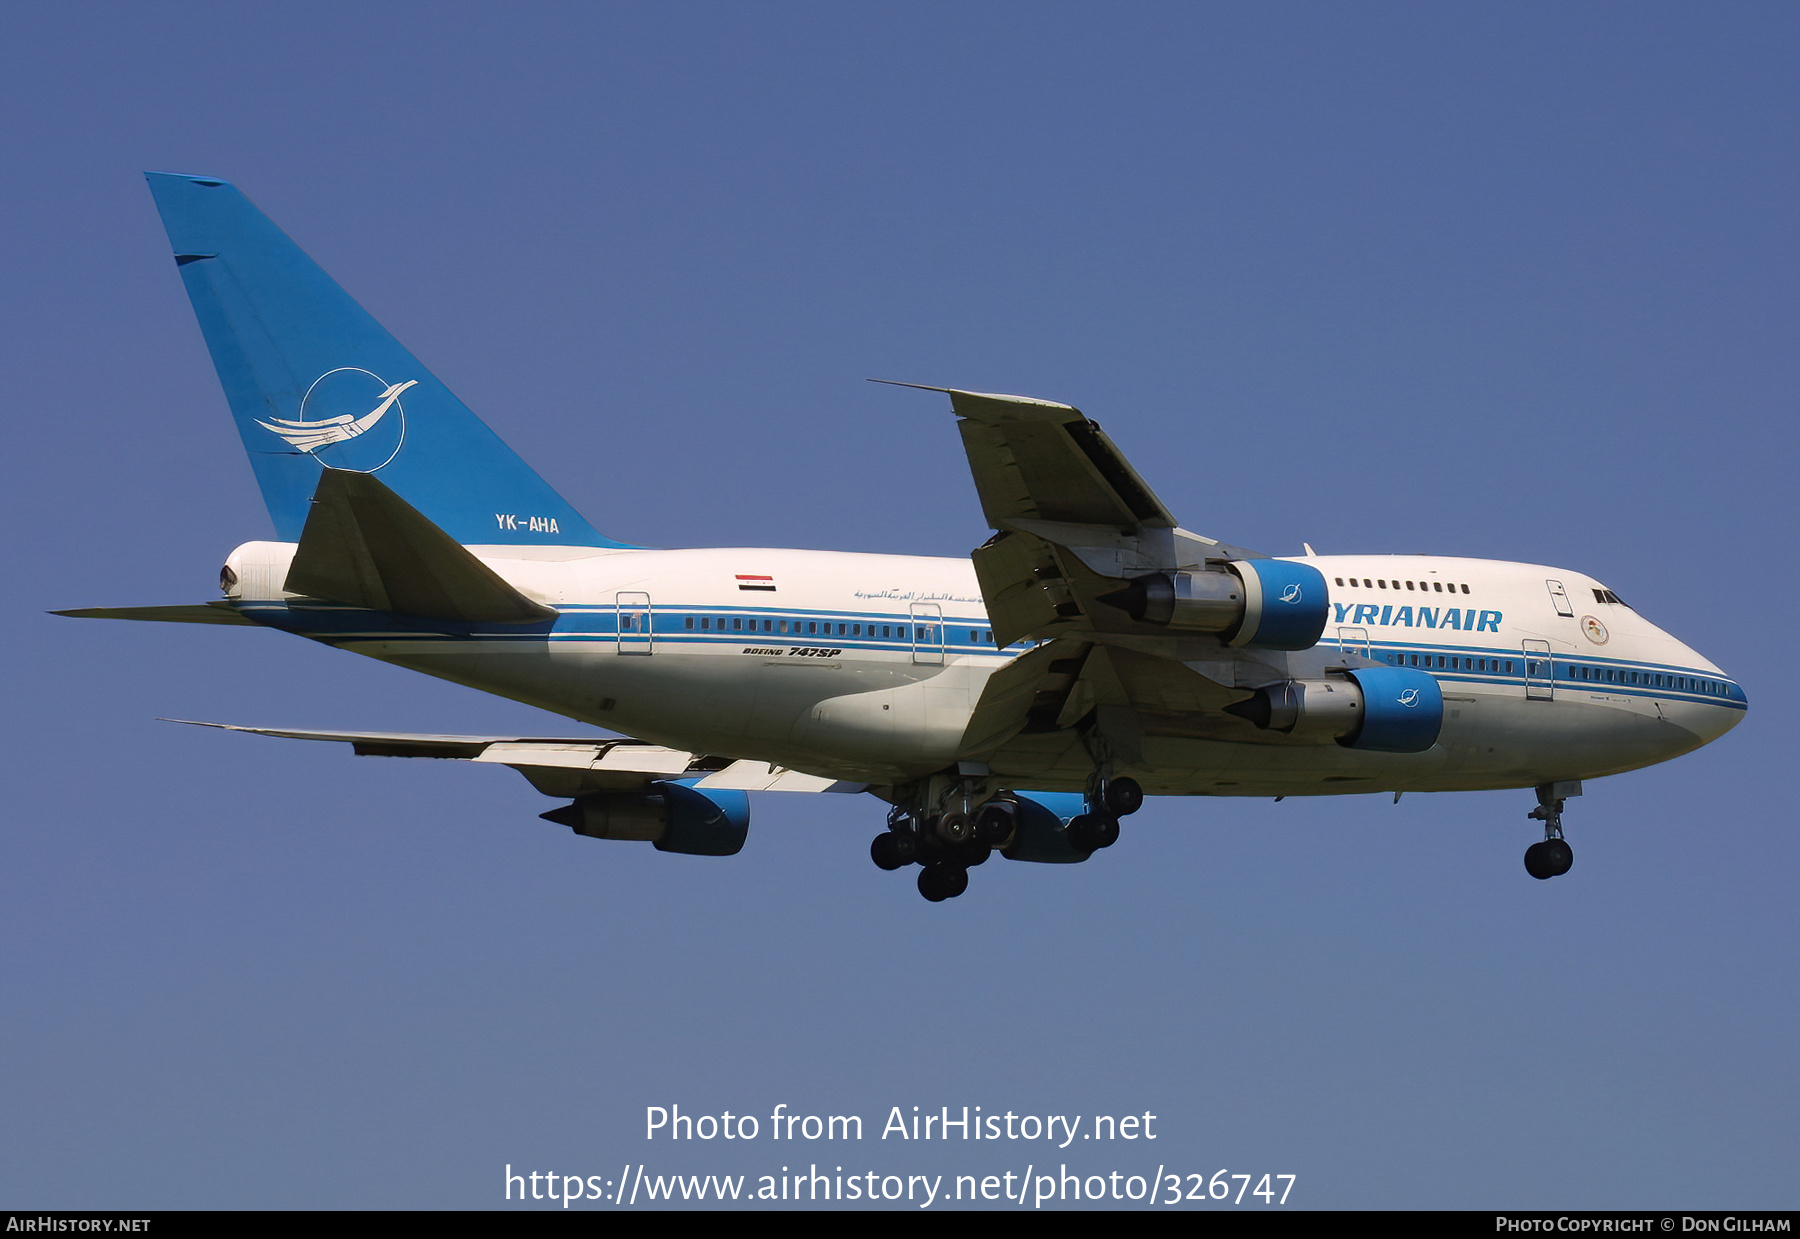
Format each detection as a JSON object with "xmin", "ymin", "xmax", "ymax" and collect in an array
[{"xmin": 164, "ymin": 719, "xmax": 868, "ymax": 798}]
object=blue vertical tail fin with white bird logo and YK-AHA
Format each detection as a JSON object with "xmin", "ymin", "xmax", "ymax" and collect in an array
[{"xmin": 146, "ymin": 173, "xmax": 625, "ymax": 547}]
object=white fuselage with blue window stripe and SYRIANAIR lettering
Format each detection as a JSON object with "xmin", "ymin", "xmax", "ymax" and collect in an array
[{"xmin": 229, "ymin": 542, "xmax": 1746, "ymax": 796}]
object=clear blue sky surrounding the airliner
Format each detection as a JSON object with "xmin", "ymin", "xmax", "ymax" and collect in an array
[{"xmin": 0, "ymin": 4, "xmax": 1800, "ymax": 1208}]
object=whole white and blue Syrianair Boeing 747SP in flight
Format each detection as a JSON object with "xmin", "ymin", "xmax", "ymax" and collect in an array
[{"xmin": 58, "ymin": 173, "xmax": 1746, "ymax": 900}]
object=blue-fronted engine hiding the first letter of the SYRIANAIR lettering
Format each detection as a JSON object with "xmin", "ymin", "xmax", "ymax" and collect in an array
[{"xmin": 1100, "ymin": 560, "xmax": 1330, "ymax": 650}]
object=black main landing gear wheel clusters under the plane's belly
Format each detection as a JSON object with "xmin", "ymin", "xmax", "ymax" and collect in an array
[{"xmin": 869, "ymin": 778, "xmax": 1143, "ymax": 904}]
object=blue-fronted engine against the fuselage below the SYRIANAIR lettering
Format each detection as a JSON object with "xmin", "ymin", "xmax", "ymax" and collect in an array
[{"xmin": 1226, "ymin": 666, "xmax": 1444, "ymax": 753}]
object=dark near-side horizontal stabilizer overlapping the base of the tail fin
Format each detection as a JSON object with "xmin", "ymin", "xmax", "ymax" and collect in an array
[{"xmin": 284, "ymin": 470, "xmax": 556, "ymax": 623}]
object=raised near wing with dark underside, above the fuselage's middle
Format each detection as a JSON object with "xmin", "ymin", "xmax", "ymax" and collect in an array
[{"xmin": 914, "ymin": 387, "xmax": 1324, "ymax": 762}]
